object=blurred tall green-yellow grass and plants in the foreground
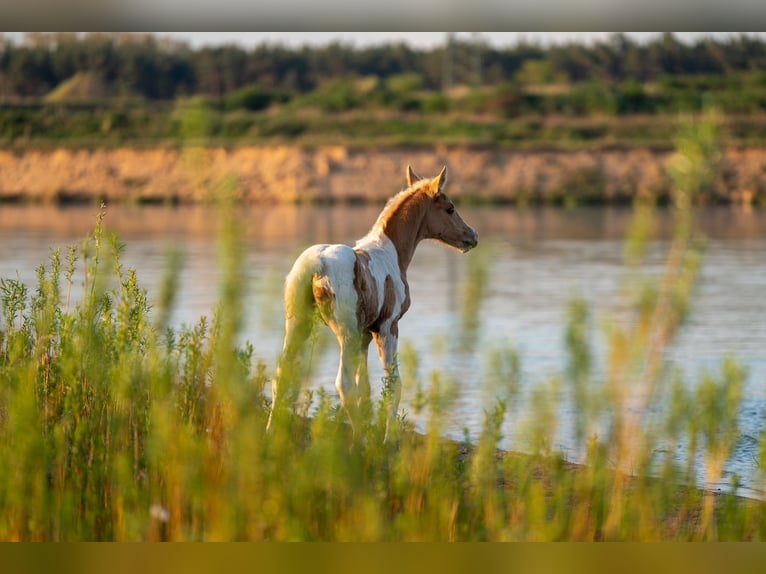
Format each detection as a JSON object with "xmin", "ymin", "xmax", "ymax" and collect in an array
[{"xmin": 0, "ymin": 111, "xmax": 766, "ymax": 541}]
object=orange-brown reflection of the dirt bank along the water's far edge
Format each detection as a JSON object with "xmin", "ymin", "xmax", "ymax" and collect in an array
[{"xmin": 0, "ymin": 204, "xmax": 766, "ymax": 243}]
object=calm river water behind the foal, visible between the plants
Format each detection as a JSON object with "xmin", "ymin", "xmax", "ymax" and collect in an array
[{"xmin": 0, "ymin": 205, "xmax": 766, "ymax": 496}]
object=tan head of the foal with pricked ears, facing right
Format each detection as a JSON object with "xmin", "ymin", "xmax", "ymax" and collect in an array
[{"xmin": 407, "ymin": 166, "xmax": 479, "ymax": 253}]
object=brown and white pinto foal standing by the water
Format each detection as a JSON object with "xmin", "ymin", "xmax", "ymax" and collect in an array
[{"xmin": 267, "ymin": 166, "xmax": 479, "ymax": 437}]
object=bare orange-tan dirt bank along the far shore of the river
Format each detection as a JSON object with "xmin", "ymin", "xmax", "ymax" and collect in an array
[{"xmin": 0, "ymin": 146, "xmax": 766, "ymax": 205}]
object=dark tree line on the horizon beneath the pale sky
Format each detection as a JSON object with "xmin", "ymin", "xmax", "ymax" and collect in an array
[{"xmin": 0, "ymin": 33, "xmax": 766, "ymax": 101}]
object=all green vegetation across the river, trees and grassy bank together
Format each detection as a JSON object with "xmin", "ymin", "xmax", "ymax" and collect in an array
[{"xmin": 0, "ymin": 33, "xmax": 766, "ymax": 146}]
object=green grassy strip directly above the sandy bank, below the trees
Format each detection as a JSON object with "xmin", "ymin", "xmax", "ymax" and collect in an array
[{"xmin": 7, "ymin": 98, "xmax": 766, "ymax": 152}]
